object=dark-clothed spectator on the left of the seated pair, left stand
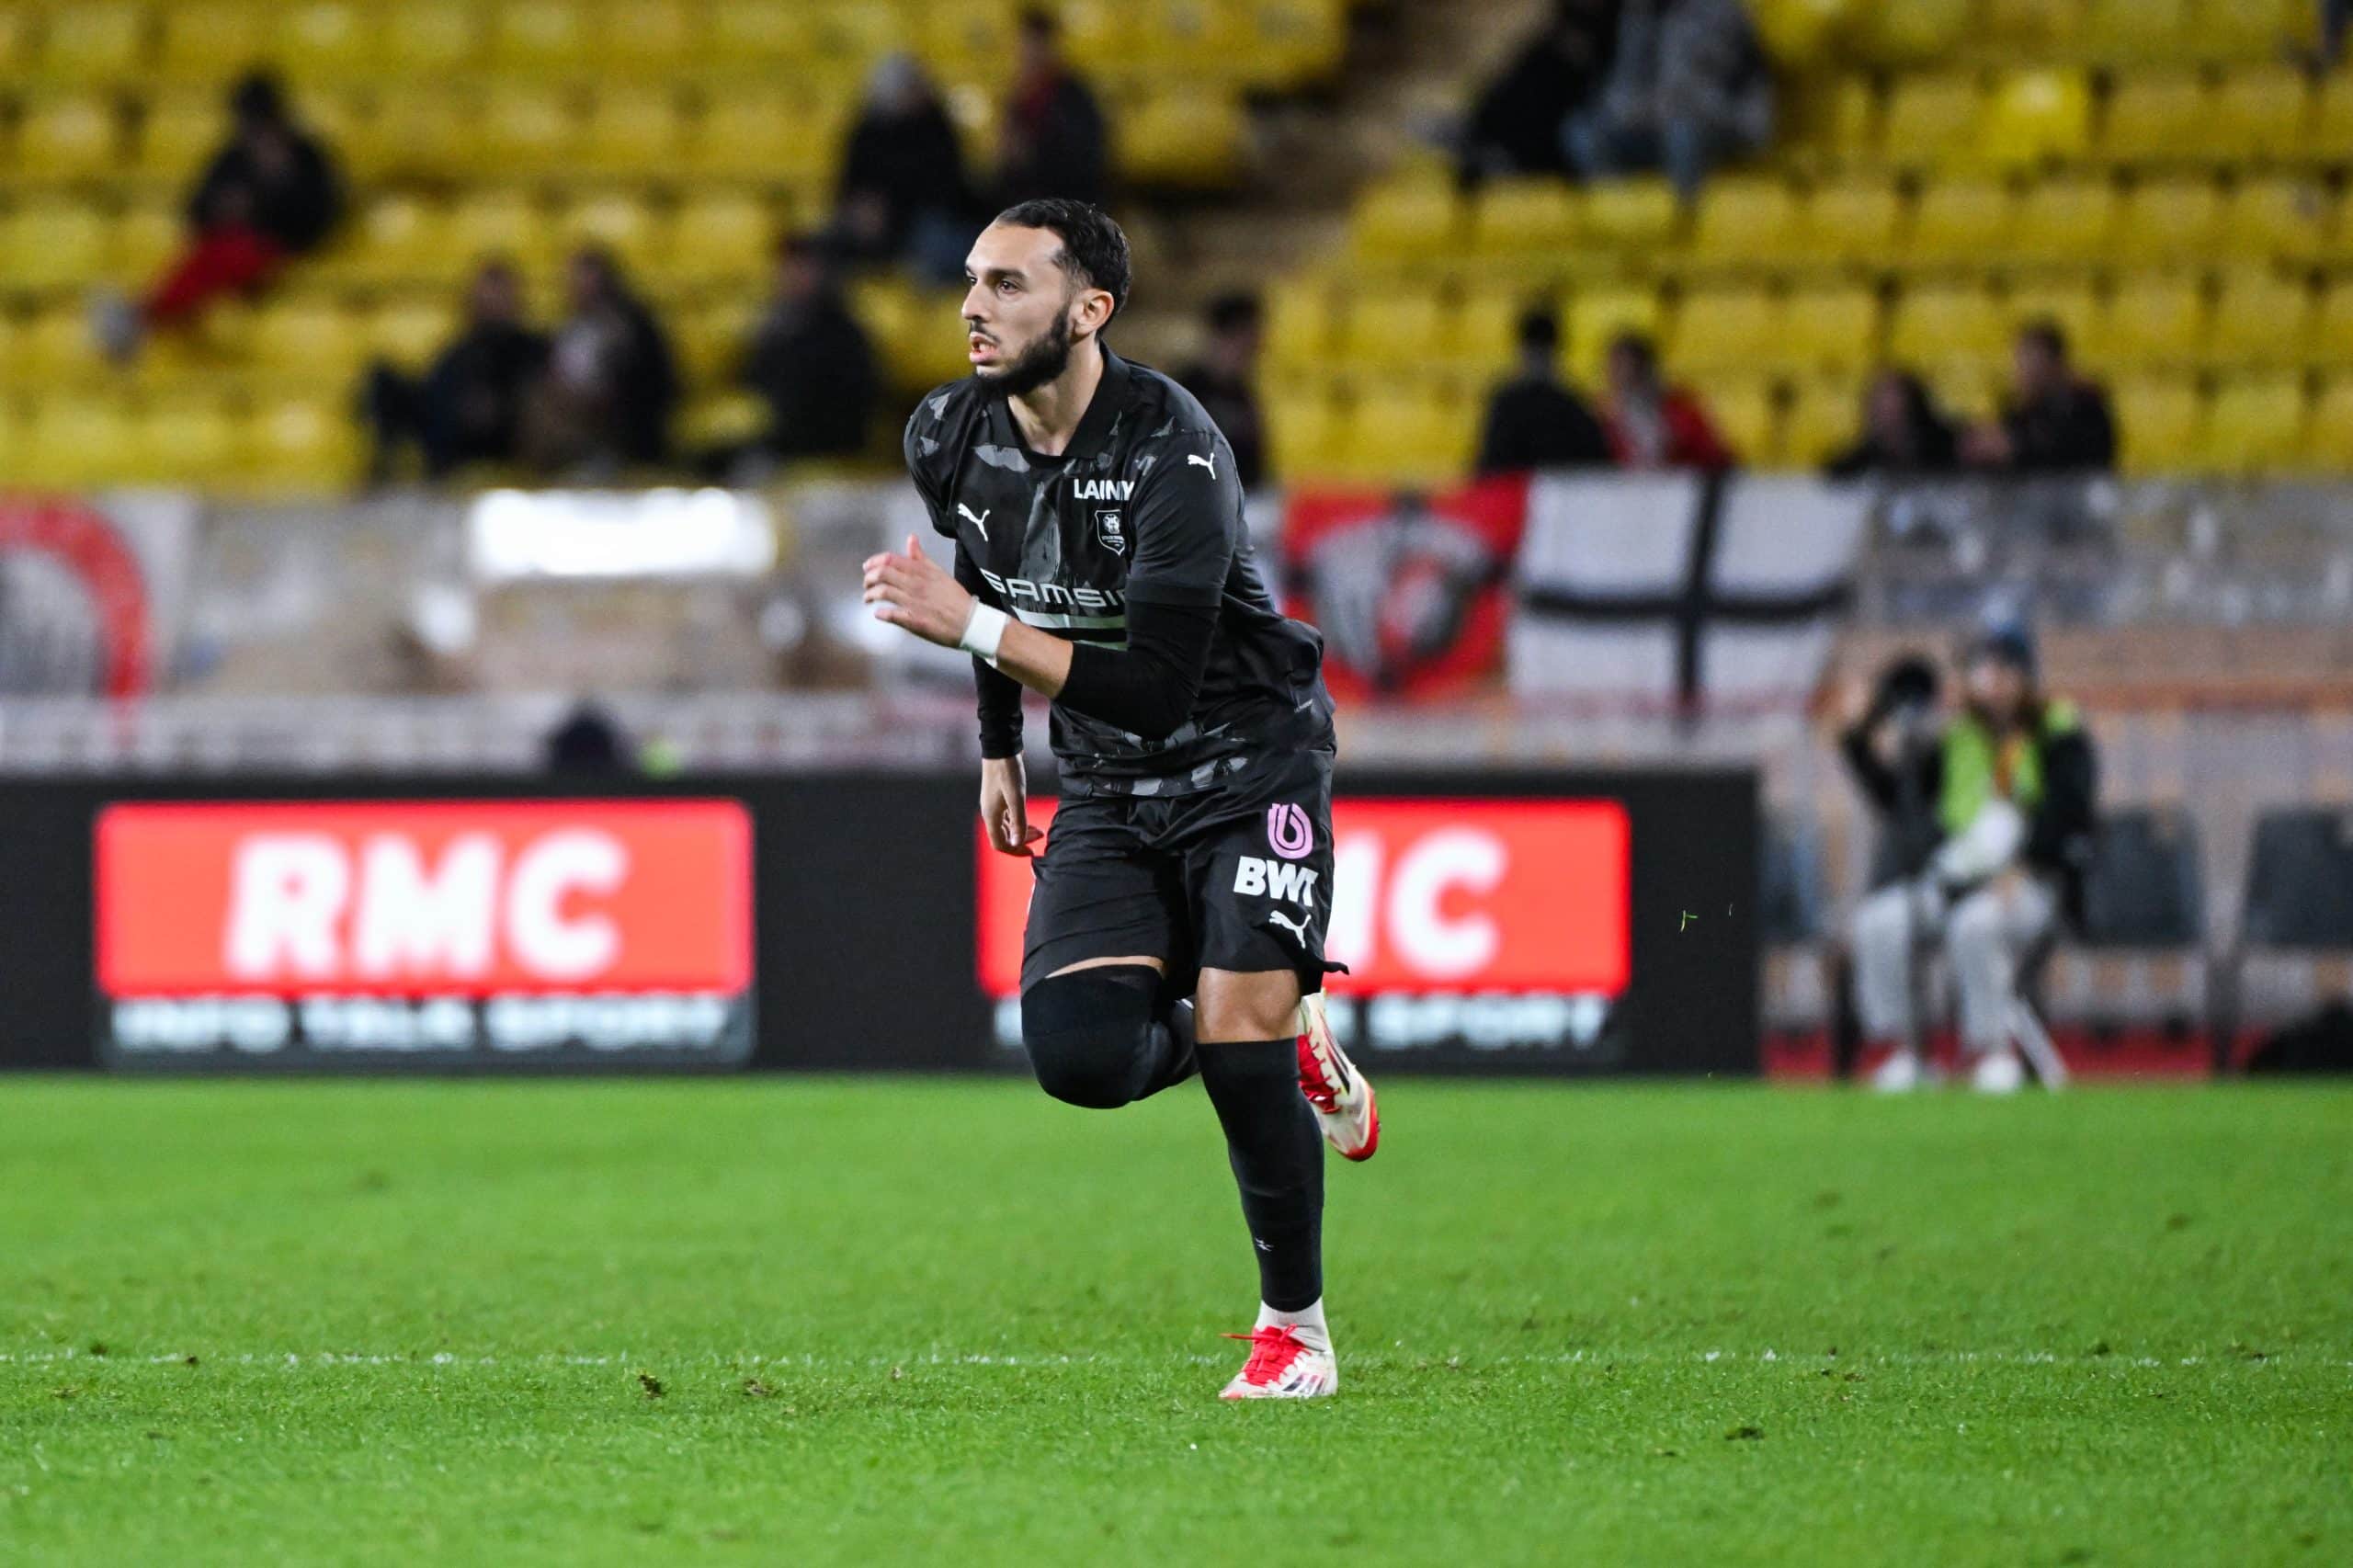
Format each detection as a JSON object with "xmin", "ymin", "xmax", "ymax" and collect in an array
[{"xmin": 365, "ymin": 261, "xmax": 548, "ymax": 483}]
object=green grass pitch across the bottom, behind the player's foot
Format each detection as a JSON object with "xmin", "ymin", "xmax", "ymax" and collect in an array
[{"xmin": 0, "ymin": 1078, "xmax": 2353, "ymax": 1568}]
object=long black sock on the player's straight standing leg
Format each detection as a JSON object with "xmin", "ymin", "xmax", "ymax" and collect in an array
[{"xmin": 1198, "ymin": 1039, "xmax": 1323, "ymax": 1312}]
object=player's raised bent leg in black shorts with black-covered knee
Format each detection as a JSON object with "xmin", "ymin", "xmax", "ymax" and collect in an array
[{"xmin": 1021, "ymin": 801, "xmax": 1195, "ymax": 1108}]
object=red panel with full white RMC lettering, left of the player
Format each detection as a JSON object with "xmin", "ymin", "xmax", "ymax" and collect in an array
[{"xmin": 97, "ymin": 801, "xmax": 753, "ymax": 998}]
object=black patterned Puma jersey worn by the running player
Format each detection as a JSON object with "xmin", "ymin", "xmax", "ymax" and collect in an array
[{"xmin": 906, "ymin": 348, "xmax": 1332, "ymax": 796}]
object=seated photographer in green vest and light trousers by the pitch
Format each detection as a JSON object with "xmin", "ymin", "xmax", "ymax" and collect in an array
[{"xmin": 1842, "ymin": 629, "xmax": 2097, "ymax": 1093}]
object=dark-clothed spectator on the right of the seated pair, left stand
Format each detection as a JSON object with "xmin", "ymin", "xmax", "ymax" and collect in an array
[{"xmin": 525, "ymin": 247, "xmax": 677, "ymax": 481}]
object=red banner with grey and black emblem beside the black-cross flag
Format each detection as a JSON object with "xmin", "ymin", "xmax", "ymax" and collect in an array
[{"xmin": 1282, "ymin": 478, "xmax": 1527, "ymax": 699}]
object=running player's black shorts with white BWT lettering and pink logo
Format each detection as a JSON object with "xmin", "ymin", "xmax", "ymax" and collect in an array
[{"xmin": 1021, "ymin": 749, "xmax": 1335, "ymax": 996}]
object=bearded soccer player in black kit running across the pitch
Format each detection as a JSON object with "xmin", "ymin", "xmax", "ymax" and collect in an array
[{"xmin": 866, "ymin": 200, "xmax": 1381, "ymax": 1399}]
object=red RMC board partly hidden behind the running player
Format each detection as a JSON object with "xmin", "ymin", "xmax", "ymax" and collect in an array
[{"xmin": 974, "ymin": 798, "xmax": 1633, "ymax": 998}]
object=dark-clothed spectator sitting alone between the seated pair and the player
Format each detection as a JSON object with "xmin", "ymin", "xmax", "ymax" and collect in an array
[{"xmin": 741, "ymin": 235, "xmax": 880, "ymax": 460}]
